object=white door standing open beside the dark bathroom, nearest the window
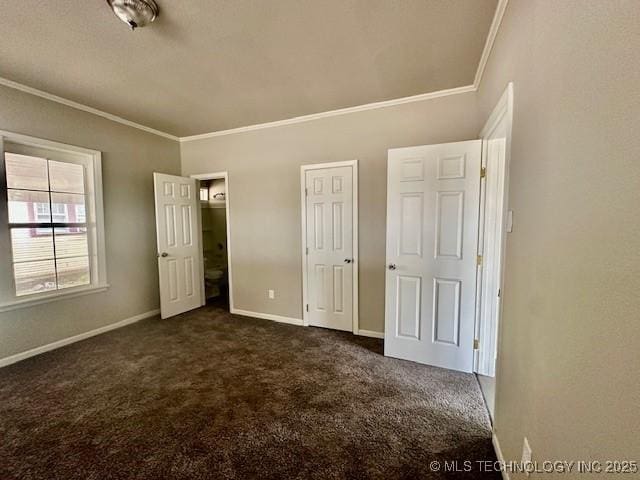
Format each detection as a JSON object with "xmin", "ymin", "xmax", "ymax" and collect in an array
[{"xmin": 153, "ymin": 173, "xmax": 203, "ymax": 318}]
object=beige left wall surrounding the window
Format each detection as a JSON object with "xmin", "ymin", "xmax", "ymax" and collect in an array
[{"xmin": 0, "ymin": 87, "xmax": 180, "ymax": 358}]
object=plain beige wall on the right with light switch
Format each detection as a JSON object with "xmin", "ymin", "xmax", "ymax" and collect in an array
[{"xmin": 478, "ymin": 0, "xmax": 640, "ymax": 472}]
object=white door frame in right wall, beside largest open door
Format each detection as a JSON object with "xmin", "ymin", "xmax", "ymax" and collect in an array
[{"xmin": 473, "ymin": 82, "xmax": 513, "ymax": 373}]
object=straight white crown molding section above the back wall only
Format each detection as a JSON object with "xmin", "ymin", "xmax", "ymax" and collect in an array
[{"xmin": 180, "ymin": 85, "xmax": 476, "ymax": 143}]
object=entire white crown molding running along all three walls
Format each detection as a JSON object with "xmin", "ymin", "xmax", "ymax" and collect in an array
[{"xmin": 0, "ymin": 0, "xmax": 509, "ymax": 143}]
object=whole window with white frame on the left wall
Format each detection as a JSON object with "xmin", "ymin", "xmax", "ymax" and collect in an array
[{"xmin": 0, "ymin": 133, "xmax": 106, "ymax": 308}]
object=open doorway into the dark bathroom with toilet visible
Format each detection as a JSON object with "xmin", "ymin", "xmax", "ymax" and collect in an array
[{"xmin": 193, "ymin": 172, "xmax": 232, "ymax": 312}]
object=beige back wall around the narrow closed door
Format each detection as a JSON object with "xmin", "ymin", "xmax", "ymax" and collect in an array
[{"xmin": 181, "ymin": 94, "xmax": 478, "ymax": 332}]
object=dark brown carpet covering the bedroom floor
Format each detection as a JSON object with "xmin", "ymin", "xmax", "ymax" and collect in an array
[{"xmin": 0, "ymin": 307, "xmax": 500, "ymax": 480}]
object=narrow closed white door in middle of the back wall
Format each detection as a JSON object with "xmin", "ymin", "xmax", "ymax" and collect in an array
[{"xmin": 305, "ymin": 166, "xmax": 355, "ymax": 331}]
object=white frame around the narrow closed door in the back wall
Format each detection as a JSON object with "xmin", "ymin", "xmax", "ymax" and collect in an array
[{"xmin": 300, "ymin": 160, "xmax": 360, "ymax": 335}]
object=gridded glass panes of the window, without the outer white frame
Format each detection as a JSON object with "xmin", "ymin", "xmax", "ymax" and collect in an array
[{"xmin": 5, "ymin": 153, "xmax": 91, "ymax": 296}]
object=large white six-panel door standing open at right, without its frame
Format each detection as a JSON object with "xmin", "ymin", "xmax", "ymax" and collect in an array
[{"xmin": 384, "ymin": 140, "xmax": 481, "ymax": 372}]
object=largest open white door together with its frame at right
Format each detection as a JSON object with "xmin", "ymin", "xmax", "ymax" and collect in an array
[{"xmin": 385, "ymin": 83, "xmax": 513, "ymax": 382}]
